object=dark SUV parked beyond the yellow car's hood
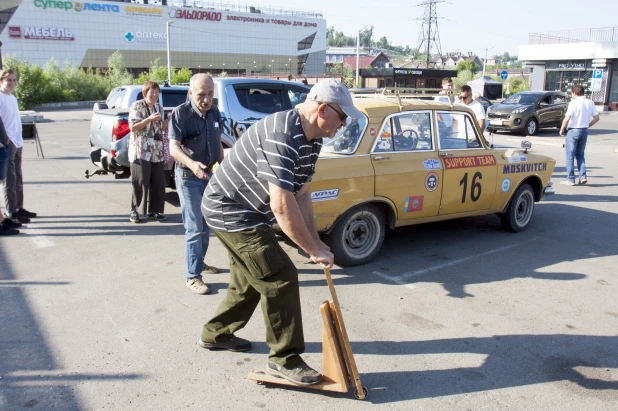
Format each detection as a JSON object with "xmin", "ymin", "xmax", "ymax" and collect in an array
[{"xmin": 487, "ymin": 91, "xmax": 569, "ymax": 136}]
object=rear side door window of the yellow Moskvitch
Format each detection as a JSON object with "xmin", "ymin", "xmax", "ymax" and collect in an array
[{"xmin": 373, "ymin": 111, "xmax": 433, "ymax": 153}]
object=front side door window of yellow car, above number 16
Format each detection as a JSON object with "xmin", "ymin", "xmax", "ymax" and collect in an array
[{"xmin": 437, "ymin": 111, "xmax": 483, "ymax": 150}]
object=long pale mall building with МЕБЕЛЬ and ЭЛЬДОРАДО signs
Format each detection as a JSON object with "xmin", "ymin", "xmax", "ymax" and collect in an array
[{"xmin": 0, "ymin": 0, "xmax": 326, "ymax": 76}]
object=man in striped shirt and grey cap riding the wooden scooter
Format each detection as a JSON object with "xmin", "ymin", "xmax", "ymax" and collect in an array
[{"xmin": 199, "ymin": 79, "xmax": 362, "ymax": 385}]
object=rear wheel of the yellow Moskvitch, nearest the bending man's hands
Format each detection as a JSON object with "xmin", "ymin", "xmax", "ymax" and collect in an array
[{"xmin": 325, "ymin": 204, "xmax": 385, "ymax": 267}]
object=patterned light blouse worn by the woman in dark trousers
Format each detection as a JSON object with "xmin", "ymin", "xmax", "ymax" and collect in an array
[{"xmin": 129, "ymin": 100, "xmax": 165, "ymax": 163}]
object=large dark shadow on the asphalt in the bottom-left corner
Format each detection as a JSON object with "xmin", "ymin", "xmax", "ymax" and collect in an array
[{"xmin": 0, "ymin": 248, "xmax": 145, "ymax": 410}]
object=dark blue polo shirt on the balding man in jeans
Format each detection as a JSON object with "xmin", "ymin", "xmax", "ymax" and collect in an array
[{"xmin": 169, "ymin": 101, "xmax": 223, "ymax": 170}]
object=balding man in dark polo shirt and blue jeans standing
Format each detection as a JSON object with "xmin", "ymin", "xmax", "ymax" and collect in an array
[{"xmin": 169, "ymin": 73, "xmax": 223, "ymax": 294}]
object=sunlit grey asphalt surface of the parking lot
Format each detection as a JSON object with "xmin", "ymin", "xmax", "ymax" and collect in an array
[{"xmin": 0, "ymin": 111, "xmax": 618, "ymax": 410}]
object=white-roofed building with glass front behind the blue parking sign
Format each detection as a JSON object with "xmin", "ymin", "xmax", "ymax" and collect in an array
[{"xmin": 518, "ymin": 27, "xmax": 618, "ymax": 110}]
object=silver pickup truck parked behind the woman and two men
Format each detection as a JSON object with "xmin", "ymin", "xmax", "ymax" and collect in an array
[{"xmin": 87, "ymin": 77, "xmax": 310, "ymax": 185}]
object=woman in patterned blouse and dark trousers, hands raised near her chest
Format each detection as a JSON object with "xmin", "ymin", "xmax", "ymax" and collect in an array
[{"xmin": 129, "ymin": 81, "xmax": 169, "ymax": 223}]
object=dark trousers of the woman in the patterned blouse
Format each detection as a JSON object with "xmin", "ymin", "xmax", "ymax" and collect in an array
[{"xmin": 131, "ymin": 159, "xmax": 165, "ymax": 215}]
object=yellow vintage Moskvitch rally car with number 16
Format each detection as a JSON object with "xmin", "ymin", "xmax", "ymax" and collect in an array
[{"xmin": 311, "ymin": 96, "xmax": 556, "ymax": 266}]
